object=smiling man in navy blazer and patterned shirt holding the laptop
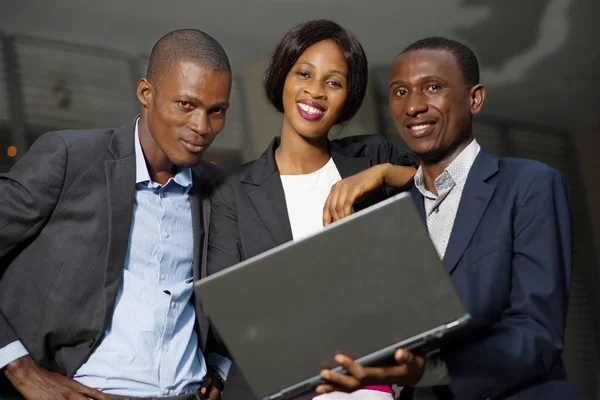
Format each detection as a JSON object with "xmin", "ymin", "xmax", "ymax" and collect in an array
[{"xmin": 318, "ymin": 38, "xmax": 579, "ymax": 400}]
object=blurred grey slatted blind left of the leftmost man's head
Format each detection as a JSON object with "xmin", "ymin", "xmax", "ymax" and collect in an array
[{"xmin": 15, "ymin": 36, "xmax": 137, "ymax": 143}]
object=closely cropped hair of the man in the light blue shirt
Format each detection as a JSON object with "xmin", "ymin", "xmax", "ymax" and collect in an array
[{"xmin": 146, "ymin": 29, "xmax": 231, "ymax": 83}]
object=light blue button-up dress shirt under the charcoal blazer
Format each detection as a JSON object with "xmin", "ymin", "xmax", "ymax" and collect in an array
[{"xmin": 0, "ymin": 123, "xmax": 231, "ymax": 397}]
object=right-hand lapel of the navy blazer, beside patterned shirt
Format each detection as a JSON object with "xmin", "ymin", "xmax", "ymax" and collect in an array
[{"xmin": 443, "ymin": 149, "xmax": 498, "ymax": 273}]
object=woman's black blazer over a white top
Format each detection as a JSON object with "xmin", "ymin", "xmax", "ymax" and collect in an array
[{"xmin": 208, "ymin": 135, "xmax": 417, "ymax": 400}]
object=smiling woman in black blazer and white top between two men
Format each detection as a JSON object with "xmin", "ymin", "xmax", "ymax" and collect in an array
[{"xmin": 207, "ymin": 20, "xmax": 415, "ymax": 400}]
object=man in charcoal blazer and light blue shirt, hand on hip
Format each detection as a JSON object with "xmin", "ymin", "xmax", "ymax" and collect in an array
[{"xmin": 0, "ymin": 29, "xmax": 231, "ymax": 400}]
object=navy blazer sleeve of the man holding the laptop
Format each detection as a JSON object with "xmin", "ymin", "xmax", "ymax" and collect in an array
[{"xmin": 444, "ymin": 170, "xmax": 572, "ymax": 399}]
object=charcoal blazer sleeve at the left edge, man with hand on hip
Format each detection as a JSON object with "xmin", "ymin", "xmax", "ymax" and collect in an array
[{"xmin": 0, "ymin": 133, "xmax": 67, "ymax": 347}]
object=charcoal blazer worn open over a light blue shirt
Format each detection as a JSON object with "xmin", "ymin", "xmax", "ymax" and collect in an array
[{"xmin": 0, "ymin": 117, "xmax": 220, "ymax": 399}]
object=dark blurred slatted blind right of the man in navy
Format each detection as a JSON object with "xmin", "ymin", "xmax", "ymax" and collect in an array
[{"xmin": 508, "ymin": 129, "xmax": 600, "ymax": 399}]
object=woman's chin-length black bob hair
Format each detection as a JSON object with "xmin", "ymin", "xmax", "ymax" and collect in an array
[{"xmin": 264, "ymin": 19, "xmax": 369, "ymax": 124}]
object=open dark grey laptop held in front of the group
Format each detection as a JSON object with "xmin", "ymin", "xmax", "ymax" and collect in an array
[{"xmin": 195, "ymin": 193, "xmax": 471, "ymax": 400}]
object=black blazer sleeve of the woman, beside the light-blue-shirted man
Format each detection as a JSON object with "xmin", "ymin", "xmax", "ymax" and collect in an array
[{"xmin": 207, "ymin": 179, "xmax": 243, "ymax": 275}]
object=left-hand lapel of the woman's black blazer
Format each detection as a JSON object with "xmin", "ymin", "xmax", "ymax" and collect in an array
[{"xmin": 241, "ymin": 137, "xmax": 293, "ymax": 245}]
